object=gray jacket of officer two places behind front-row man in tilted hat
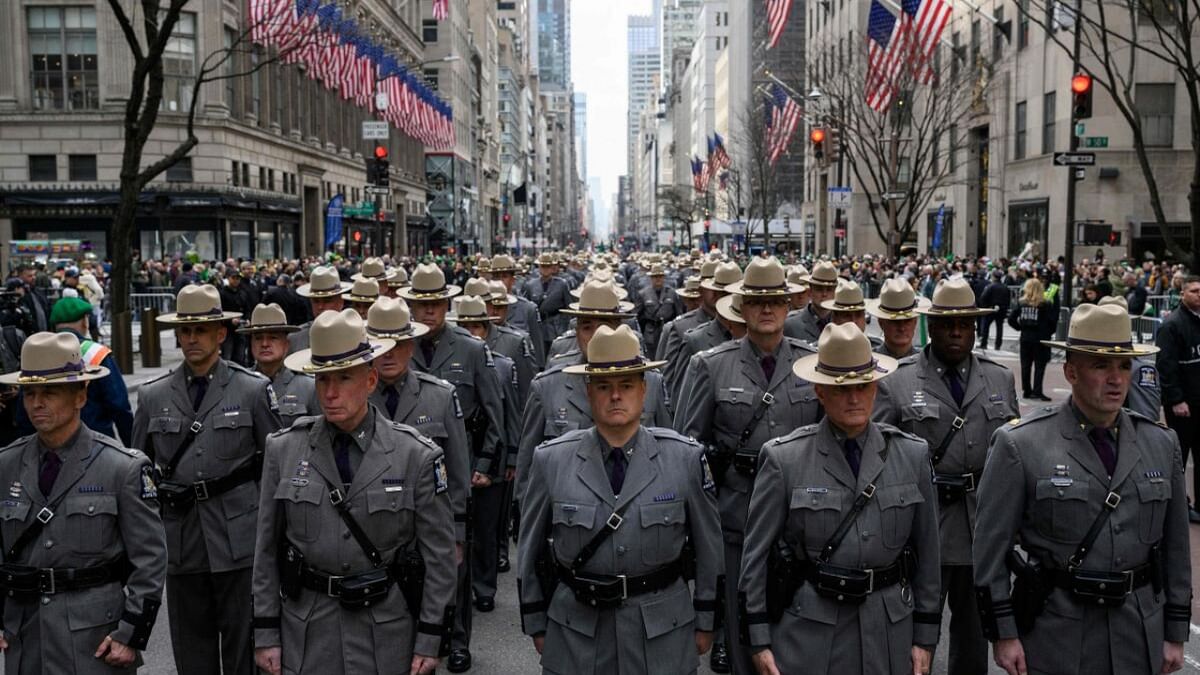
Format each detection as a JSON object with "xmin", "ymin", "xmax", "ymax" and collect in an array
[{"xmin": 410, "ymin": 324, "xmax": 504, "ymax": 476}]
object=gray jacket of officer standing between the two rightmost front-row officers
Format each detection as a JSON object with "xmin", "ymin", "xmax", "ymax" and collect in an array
[{"xmin": 872, "ymin": 347, "xmax": 1021, "ymax": 565}]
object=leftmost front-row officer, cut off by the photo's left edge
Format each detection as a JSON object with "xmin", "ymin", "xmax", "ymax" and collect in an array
[{"xmin": 0, "ymin": 331, "xmax": 167, "ymax": 675}]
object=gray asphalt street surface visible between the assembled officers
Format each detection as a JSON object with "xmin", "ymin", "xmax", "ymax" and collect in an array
[{"xmin": 21, "ymin": 352, "xmax": 1200, "ymax": 675}]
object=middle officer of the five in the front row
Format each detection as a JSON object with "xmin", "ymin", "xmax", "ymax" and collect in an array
[{"xmin": 517, "ymin": 325, "xmax": 722, "ymax": 675}]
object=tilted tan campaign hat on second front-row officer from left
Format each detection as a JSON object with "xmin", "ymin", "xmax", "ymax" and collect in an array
[{"xmin": 283, "ymin": 310, "xmax": 396, "ymax": 375}]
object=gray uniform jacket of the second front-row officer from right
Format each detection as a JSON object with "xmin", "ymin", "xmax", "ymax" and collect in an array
[{"xmin": 738, "ymin": 422, "xmax": 941, "ymax": 675}]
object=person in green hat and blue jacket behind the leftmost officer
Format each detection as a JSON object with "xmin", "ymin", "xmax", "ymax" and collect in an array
[{"xmin": 16, "ymin": 298, "xmax": 133, "ymax": 443}]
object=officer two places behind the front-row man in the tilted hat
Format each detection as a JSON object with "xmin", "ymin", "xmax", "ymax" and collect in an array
[{"xmin": 400, "ymin": 264, "xmax": 505, "ymax": 673}]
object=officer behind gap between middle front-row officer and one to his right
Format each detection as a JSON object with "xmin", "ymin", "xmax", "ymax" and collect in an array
[{"xmin": 674, "ymin": 257, "xmax": 820, "ymax": 674}]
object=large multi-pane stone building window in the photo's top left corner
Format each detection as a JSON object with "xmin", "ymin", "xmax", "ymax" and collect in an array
[{"xmin": 29, "ymin": 7, "xmax": 100, "ymax": 110}]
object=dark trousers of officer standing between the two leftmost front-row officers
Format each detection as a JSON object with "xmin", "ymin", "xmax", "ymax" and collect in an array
[{"xmin": 167, "ymin": 567, "xmax": 256, "ymax": 675}]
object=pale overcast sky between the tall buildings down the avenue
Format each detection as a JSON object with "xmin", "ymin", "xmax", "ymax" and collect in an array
[{"xmin": 571, "ymin": 0, "xmax": 650, "ymax": 236}]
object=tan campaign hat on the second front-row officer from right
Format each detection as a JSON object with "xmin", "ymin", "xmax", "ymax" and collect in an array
[{"xmin": 792, "ymin": 323, "xmax": 896, "ymax": 387}]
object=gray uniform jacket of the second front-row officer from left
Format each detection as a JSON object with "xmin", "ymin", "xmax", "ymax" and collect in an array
[{"xmin": 253, "ymin": 412, "xmax": 456, "ymax": 675}]
